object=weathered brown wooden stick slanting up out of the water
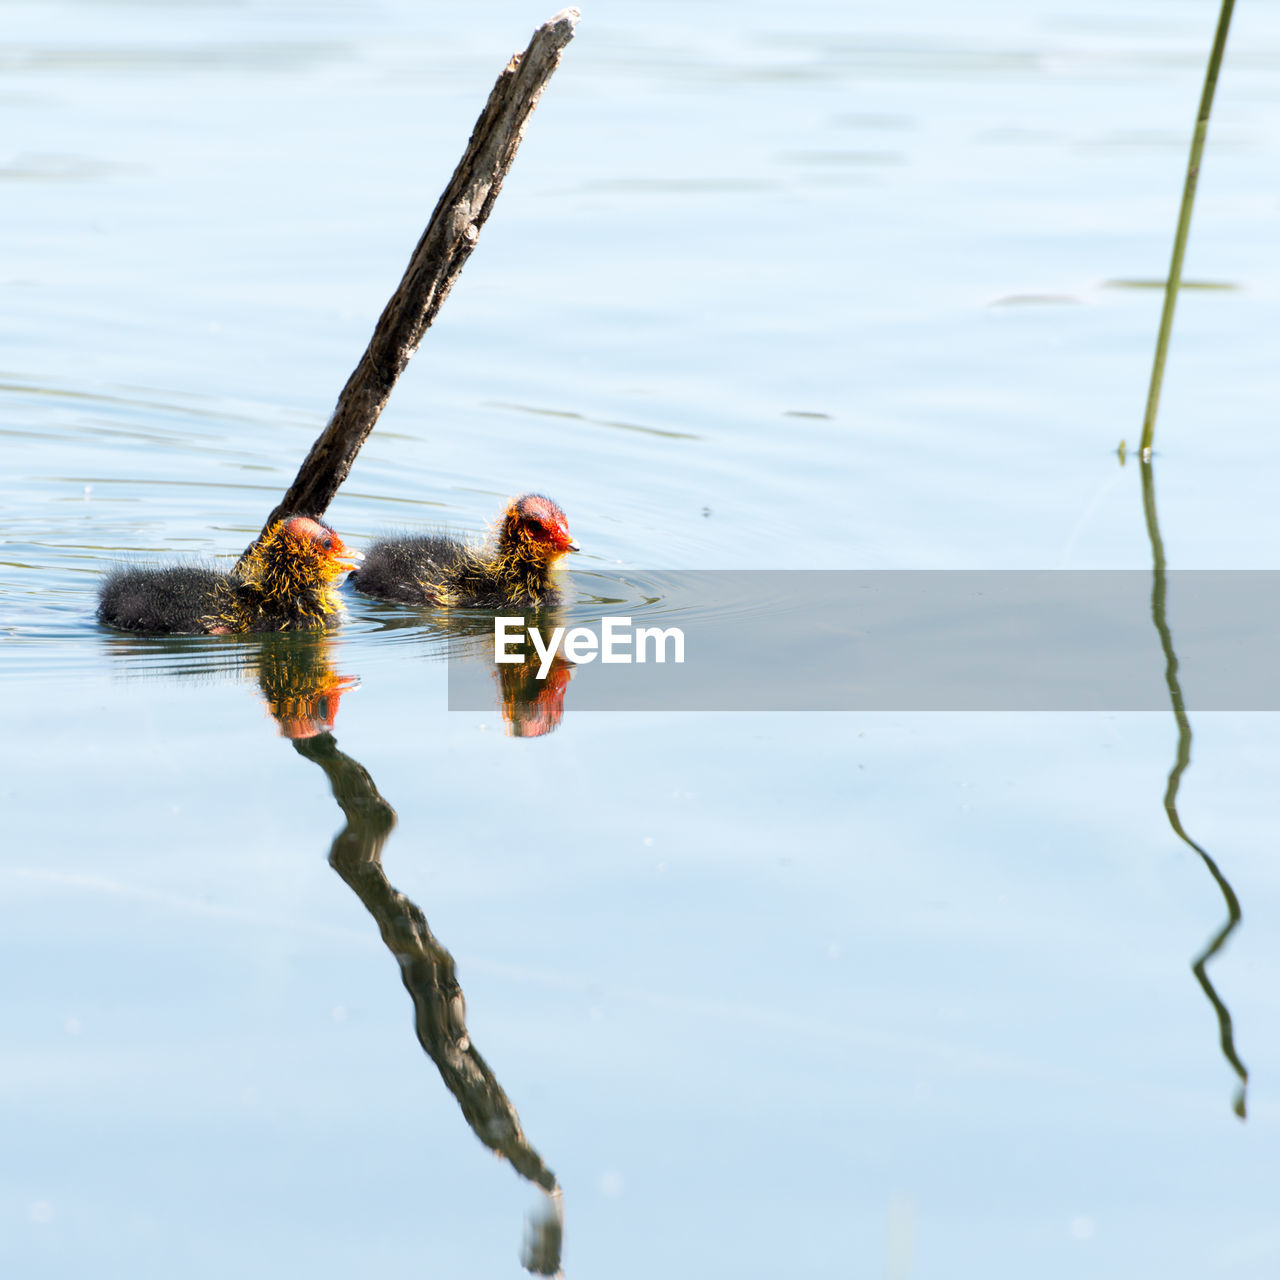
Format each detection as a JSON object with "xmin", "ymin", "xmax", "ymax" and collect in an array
[{"xmin": 243, "ymin": 9, "xmax": 579, "ymax": 550}]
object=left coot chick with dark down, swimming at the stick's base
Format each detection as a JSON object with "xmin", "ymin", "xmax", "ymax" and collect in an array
[{"xmin": 97, "ymin": 516, "xmax": 358, "ymax": 636}]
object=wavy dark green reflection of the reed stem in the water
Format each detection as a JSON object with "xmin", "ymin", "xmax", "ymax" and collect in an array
[{"xmin": 1139, "ymin": 458, "xmax": 1249, "ymax": 1120}]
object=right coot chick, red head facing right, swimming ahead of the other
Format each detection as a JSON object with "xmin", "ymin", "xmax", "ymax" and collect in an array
[{"xmin": 351, "ymin": 493, "xmax": 579, "ymax": 609}]
